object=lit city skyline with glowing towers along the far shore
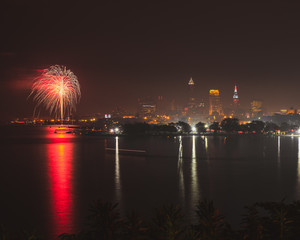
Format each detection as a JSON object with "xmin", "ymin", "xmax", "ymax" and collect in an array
[{"xmin": 4, "ymin": 77, "xmax": 299, "ymax": 122}]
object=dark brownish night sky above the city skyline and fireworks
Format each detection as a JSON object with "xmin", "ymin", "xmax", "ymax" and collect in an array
[{"xmin": 0, "ymin": 0, "xmax": 300, "ymax": 118}]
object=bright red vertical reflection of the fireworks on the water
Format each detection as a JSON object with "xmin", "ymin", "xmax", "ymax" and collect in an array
[{"xmin": 48, "ymin": 129, "xmax": 74, "ymax": 236}]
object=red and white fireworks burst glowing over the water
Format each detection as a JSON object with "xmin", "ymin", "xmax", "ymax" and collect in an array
[{"xmin": 30, "ymin": 65, "xmax": 81, "ymax": 120}]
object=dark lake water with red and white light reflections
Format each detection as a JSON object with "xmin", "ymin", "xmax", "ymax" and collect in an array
[{"xmin": 0, "ymin": 127, "xmax": 300, "ymax": 239}]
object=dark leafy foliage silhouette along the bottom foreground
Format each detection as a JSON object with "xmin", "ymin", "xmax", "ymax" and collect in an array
[{"xmin": 5, "ymin": 200, "xmax": 300, "ymax": 240}]
